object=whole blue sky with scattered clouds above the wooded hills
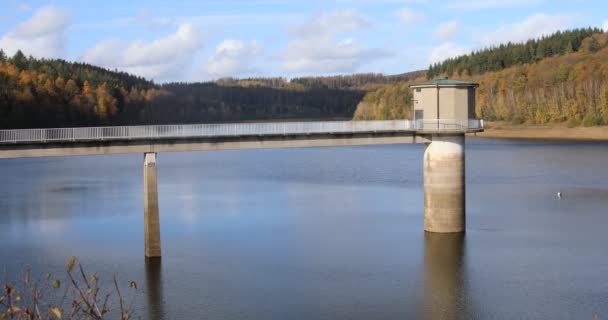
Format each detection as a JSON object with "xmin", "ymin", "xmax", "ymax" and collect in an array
[{"xmin": 0, "ymin": 0, "xmax": 608, "ymax": 82}]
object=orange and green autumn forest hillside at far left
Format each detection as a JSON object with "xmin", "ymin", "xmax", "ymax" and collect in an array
[{"xmin": 0, "ymin": 50, "xmax": 163, "ymax": 128}]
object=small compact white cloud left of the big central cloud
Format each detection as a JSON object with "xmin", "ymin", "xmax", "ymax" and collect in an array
[{"xmin": 206, "ymin": 39, "xmax": 262, "ymax": 77}]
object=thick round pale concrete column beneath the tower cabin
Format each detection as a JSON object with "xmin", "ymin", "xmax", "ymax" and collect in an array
[{"xmin": 424, "ymin": 134, "xmax": 465, "ymax": 233}]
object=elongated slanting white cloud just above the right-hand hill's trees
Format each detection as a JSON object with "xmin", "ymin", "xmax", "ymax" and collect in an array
[{"xmin": 477, "ymin": 13, "xmax": 572, "ymax": 46}]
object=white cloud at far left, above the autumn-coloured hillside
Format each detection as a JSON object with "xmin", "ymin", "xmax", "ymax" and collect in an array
[{"xmin": 0, "ymin": 6, "xmax": 70, "ymax": 58}]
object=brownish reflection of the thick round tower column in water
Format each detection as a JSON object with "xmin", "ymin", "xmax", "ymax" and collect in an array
[{"xmin": 424, "ymin": 232, "xmax": 468, "ymax": 319}]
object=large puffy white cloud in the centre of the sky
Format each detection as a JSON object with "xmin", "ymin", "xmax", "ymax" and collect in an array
[{"xmin": 283, "ymin": 10, "xmax": 387, "ymax": 74}]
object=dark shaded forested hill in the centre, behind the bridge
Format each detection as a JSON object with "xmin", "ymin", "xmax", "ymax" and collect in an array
[{"xmin": 146, "ymin": 83, "xmax": 365, "ymax": 123}]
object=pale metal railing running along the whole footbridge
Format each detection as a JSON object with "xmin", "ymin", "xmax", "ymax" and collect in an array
[{"xmin": 0, "ymin": 120, "xmax": 483, "ymax": 143}]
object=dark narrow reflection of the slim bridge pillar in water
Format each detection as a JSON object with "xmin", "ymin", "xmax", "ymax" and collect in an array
[{"xmin": 146, "ymin": 258, "xmax": 164, "ymax": 320}]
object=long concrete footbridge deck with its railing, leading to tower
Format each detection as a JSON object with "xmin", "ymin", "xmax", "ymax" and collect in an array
[{"xmin": 0, "ymin": 120, "xmax": 483, "ymax": 158}]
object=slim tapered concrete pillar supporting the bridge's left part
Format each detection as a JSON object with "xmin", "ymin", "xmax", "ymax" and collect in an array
[{"xmin": 144, "ymin": 153, "xmax": 160, "ymax": 258}]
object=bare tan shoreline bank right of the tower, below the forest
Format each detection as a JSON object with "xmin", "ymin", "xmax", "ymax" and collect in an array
[{"xmin": 476, "ymin": 122, "xmax": 608, "ymax": 141}]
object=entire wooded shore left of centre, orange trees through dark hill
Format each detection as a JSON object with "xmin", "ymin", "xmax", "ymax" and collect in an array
[{"xmin": 0, "ymin": 50, "xmax": 364, "ymax": 129}]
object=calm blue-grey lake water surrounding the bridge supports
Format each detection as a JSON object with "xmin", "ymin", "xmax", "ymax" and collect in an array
[{"xmin": 0, "ymin": 138, "xmax": 608, "ymax": 319}]
